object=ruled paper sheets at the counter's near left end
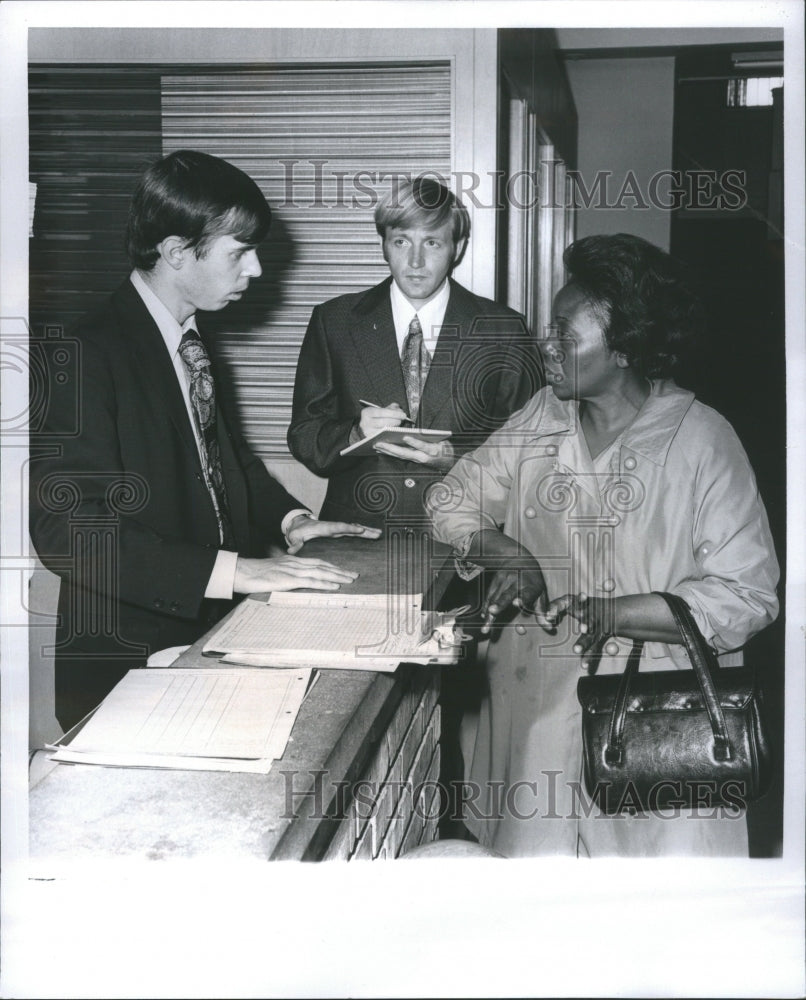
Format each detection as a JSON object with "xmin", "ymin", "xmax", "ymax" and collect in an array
[{"xmin": 50, "ymin": 667, "xmax": 311, "ymax": 774}]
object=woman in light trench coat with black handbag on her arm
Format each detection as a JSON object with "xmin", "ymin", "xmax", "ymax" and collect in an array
[{"xmin": 430, "ymin": 234, "xmax": 778, "ymax": 856}]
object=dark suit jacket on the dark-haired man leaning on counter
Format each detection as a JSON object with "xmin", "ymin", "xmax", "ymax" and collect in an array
[{"xmin": 30, "ymin": 280, "xmax": 304, "ymax": 724}]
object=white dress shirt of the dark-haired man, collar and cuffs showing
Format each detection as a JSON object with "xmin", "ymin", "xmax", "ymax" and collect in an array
[{"xmin": 130, "ymin": 271, "xmax": 311, "ymax": 600}]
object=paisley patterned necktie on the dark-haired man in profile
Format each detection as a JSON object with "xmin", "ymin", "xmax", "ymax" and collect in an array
[{"xmin": 179, "ymin": 329, "xmax": 235, "ymax": 550}]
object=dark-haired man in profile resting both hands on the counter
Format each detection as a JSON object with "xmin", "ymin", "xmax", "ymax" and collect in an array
[{"xmin": 30, "ymin": 150, "xmax": 379, "ymax": 727}]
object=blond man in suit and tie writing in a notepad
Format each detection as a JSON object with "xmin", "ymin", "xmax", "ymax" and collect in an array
[{"xmin": 288, "ymin": 177, "xmax": 543, "ymax": 526}]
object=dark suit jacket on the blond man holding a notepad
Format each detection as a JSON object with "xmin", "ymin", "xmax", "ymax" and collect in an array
[{"xmin": 288, "ymin": 278, "xmax": 543, "ymax": 525}]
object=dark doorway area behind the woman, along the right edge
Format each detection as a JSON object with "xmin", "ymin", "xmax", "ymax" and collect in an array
[{"xmin": 671, "ymin": 46, "xmax": 786, "ymax": 857}]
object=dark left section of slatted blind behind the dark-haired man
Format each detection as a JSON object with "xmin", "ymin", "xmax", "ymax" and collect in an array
[{"xmin": 28, "ymin": 65, "xmax": 162, "ymax": 334}]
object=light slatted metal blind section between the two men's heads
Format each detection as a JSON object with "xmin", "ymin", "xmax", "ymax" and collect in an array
[{"xmin": 162, "ymin": 61, "xmax": 452, "ymax": 458}]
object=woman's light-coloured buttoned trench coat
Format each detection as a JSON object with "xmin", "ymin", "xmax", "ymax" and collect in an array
[{"xmin": 430, "ymin": 380, "xmax": 778, "ymax": 856}]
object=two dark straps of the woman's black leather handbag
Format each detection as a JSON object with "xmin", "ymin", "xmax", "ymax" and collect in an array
[{"xmin": 604, "ymin": 590, "xmax": 734, "ymax": 765}]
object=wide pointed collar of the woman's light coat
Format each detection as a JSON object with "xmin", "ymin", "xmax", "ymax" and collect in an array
[{"xmin": 534, "ymin": 379, "xmax": 694, "ymax": 465}]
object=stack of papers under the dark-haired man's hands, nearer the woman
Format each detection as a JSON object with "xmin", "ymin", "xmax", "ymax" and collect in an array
[{"xmin": 203, "ymin": 591, "xmax": 456, "ymax": 671}]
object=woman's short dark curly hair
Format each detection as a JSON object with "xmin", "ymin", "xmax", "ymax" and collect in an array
[{"xmin": 563, "ymin": 233, "xmax": 705, "ymax": 378}]
